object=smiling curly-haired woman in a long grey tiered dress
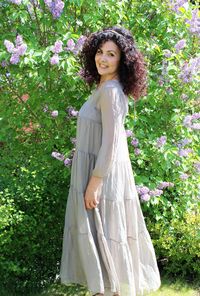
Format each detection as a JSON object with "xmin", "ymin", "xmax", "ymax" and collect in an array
[{"xmin": 60, "ymin": 26, "xmax": 160, "ymax": 296}]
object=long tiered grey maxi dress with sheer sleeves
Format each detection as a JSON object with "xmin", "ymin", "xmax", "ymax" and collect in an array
[{"xmin": 60, "ymin": 80, "xmax": 161, "ymax": 296}]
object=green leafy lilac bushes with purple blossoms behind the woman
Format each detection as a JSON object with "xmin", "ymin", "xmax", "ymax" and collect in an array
[{"xmin": 0, "ymin": 0, "xmax": 200, "ymax": 295}]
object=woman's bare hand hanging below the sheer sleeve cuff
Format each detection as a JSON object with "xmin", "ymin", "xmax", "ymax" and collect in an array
[{"xmin": 84, "ymin": 176, "xmax": 102, "ymax": 210}]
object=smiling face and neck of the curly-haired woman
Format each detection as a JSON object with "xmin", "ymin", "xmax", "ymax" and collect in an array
[{"xmin": 95, "ymin": 40, "xmax": 121, "ymax": 81}]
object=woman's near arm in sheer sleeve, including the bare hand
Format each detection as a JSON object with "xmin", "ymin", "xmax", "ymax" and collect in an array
[{"xmin": 85, "ymin": 87, "xmax": 122, "ymax": 209}]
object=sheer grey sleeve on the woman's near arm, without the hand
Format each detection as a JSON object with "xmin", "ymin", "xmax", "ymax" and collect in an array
[{"xmin": 92, "ymin": 87, "xmax": 123, "ymax": 177}]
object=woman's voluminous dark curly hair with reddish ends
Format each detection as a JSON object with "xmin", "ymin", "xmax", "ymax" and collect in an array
[{"xmin": 78, "ymin": 26, "xmax": 147, "ymax": 101}]
